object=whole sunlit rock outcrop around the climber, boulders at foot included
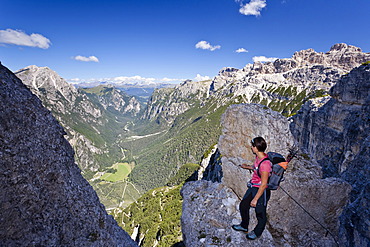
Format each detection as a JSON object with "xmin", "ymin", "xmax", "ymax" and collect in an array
[{"xmin": 182, "ymin": 104, "xmax": 351, "ymax": 246}]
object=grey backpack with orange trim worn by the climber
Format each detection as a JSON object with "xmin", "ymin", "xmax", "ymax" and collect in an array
[{"xmin": 257, "ymin": 152, "xmax": 289, "ymax": 190}]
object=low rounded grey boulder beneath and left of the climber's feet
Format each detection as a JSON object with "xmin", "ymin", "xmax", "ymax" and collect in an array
[{"xmin": 181, "ymin": 180, "xmax": 274, "ymax": 247}]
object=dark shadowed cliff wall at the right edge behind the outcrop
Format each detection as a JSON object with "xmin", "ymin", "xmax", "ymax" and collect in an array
[{"xmin": 291, "ymin": 65, "xmax": 370, "ymax": 246}]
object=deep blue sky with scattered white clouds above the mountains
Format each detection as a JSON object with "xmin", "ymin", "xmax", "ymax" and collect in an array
[{"xmin": 0, "ymin": 0, "xmax": 370, "ymax": 82}]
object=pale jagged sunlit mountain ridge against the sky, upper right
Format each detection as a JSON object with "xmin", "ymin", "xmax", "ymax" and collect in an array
[{"xmin": 144, "ymin": 43, "xmax": 370, "ymax": 125}]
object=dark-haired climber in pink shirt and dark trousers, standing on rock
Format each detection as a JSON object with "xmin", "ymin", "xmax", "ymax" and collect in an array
[{"xmin": 232, "ymin": 137, "xmax": 271, "ymax": 240}]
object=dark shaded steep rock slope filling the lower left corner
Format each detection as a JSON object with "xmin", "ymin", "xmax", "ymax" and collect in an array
[{"xmin": 0, "ymin": 65, "xmax": 137, "ymax": 246}]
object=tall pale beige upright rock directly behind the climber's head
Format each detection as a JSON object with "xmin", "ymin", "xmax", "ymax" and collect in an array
[{"xmin": 219, "ymin": 104, "xmax": 294, "ymax": 197}]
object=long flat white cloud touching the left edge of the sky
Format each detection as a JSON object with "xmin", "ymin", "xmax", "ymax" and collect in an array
[{"xmin": 0, "ymin": 29, "xmax": 51, "ymax": 49}]
